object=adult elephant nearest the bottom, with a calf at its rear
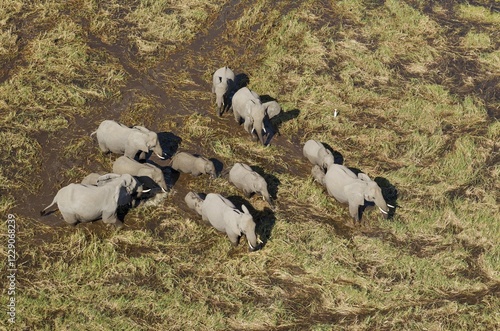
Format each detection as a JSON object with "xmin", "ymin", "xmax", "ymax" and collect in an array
[{"xmin": 201, "ymin": 193, "xmax": 260, "ymax": 251}]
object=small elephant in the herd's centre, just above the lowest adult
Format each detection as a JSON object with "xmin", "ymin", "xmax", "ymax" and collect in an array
[{"xmin": 229, "ymin": 163, "xmax": 273, "ymax": 207}]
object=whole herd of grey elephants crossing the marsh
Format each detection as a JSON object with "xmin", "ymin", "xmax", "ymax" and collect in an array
[{"xmin": 40, "ymin": 67, "xmax": 394, "ymax": 251}]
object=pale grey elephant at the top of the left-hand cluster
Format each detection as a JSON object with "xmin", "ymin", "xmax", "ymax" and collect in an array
[{"xmin": 90, "ymin": 120, "xmax": 165, "ymax": 159}]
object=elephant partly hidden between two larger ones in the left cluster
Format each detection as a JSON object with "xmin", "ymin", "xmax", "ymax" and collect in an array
[{"xmin": 113, "ymin": 156, "xmax": 168, "ymax": 192}]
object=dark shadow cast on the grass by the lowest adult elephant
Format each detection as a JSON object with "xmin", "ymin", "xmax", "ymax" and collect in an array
[{"xmin": 227, "ymin": 195, "xmax": 276, "ymax": 248}]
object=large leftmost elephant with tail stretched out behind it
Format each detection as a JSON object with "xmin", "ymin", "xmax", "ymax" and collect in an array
[{"xmin": 40, "ymin": 174, "xmax": 142, "ymax": 228}]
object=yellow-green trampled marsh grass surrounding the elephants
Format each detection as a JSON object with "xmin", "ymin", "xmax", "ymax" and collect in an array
[{"xmin": 0, "ymin": 0, "xmax": 500, "ymax": 330}]
